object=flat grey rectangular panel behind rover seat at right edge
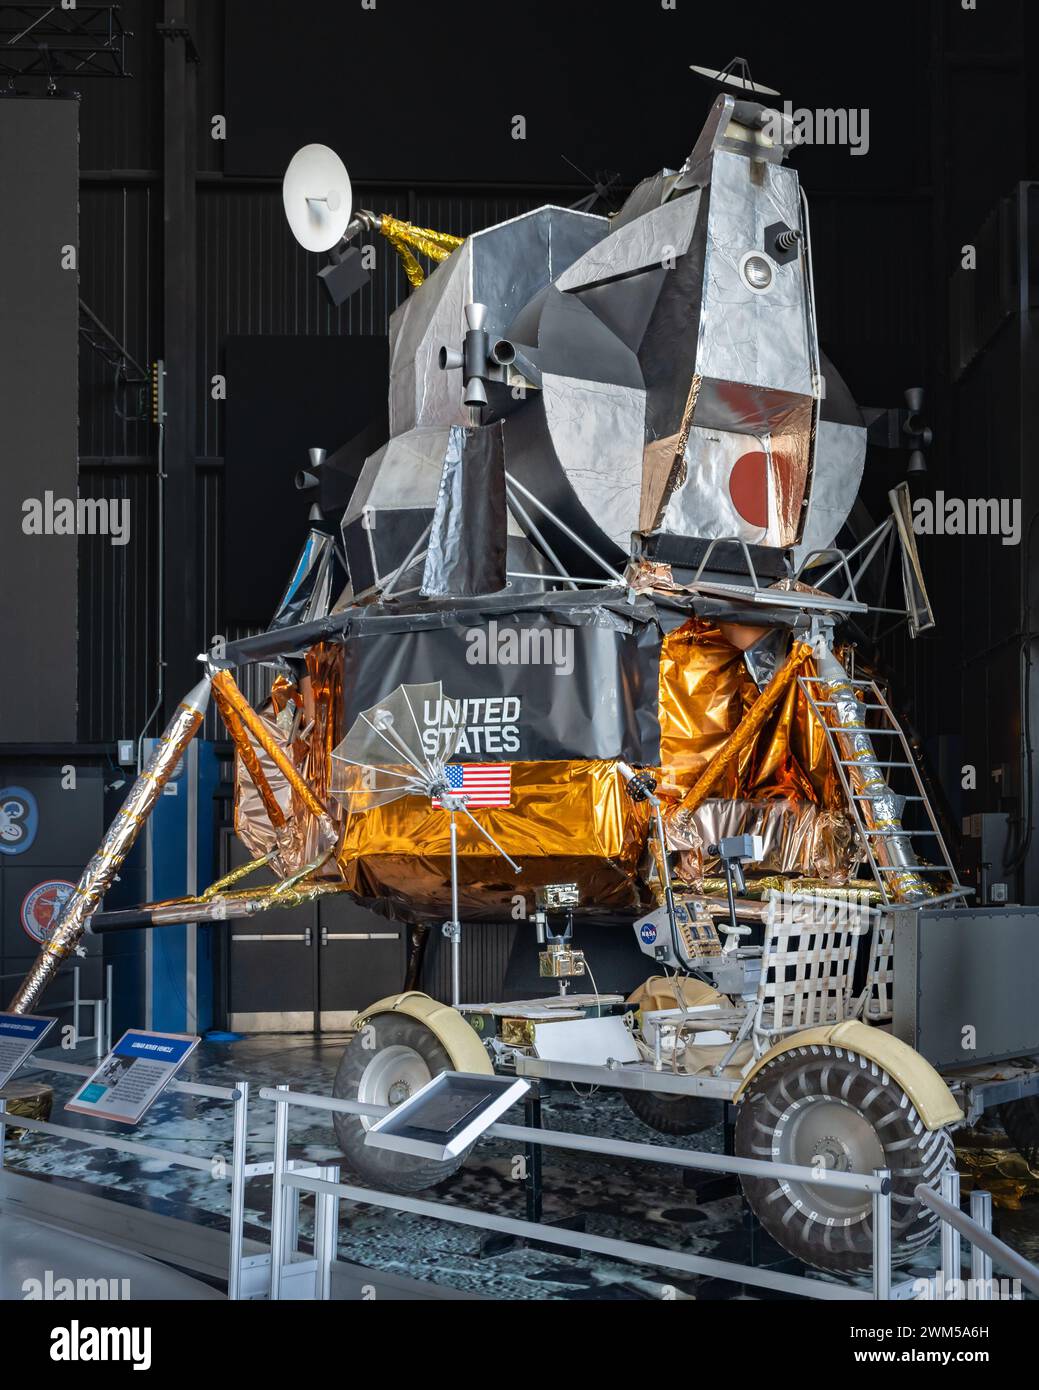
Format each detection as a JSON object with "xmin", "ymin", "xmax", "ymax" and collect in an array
[{"xmin": 894, "ymin": 908, "xmax": 1039, "ymax": 1069}]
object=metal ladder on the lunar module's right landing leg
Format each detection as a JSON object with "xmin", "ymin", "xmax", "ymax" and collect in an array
[{"xmin": 797, "ymin": 676, "xmax": 969, "ymax": 908}]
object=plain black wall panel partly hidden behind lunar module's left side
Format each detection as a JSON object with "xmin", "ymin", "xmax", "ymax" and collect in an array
[{"xmin": 224, "ymin": 336, "xmax": 388, "ymax": 624}]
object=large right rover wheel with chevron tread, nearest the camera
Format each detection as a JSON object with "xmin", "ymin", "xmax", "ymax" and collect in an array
[{"xmin": 736, "ymin": 1045, "xmax": 954, "ymax": 1273}]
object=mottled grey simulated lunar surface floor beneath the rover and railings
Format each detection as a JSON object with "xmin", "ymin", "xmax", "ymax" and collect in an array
[{"xmin": 6, "ymin": 1034, "xmax": 1039, "ymax": 1300}]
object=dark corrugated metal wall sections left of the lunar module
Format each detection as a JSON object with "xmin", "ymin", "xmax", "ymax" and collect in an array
[{"xmin": 79, "ymin": 169, "xmax": 556, "ymax": 741}]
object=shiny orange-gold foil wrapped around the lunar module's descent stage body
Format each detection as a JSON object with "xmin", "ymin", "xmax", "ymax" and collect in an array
[{"xmin": 229, "ymin": 619, "xmax": 879, "ymax": 920}]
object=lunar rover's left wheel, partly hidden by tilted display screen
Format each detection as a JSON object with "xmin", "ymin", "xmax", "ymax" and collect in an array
[{"xmin": 332, "ymin": 1013, "xmax": 466, "ymax": 1193}]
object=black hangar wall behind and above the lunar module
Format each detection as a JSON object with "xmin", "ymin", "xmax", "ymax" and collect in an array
[{"xmin": 10, "ymin": 0, "xmax": 1039, "ymax": 889}]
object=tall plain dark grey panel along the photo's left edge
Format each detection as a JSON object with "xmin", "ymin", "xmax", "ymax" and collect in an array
[{"xmin": 0, "ymin": 97, "xmax": 79, "ymax": 742}]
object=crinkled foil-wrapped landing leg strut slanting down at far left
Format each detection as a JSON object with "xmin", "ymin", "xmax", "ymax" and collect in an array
[{"xmin": 8, "ymin": 678, "xmax": 210, "ymax": 1013}]
